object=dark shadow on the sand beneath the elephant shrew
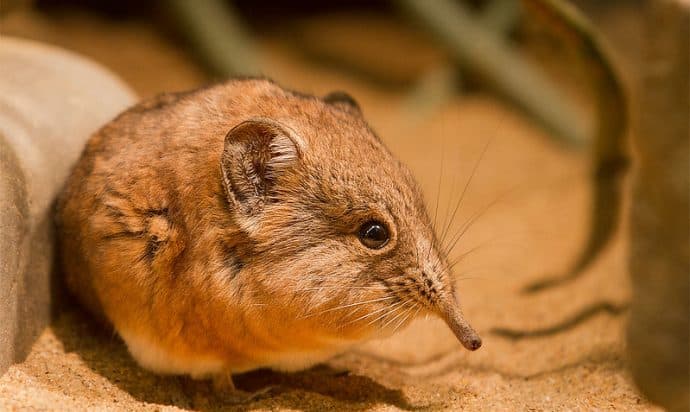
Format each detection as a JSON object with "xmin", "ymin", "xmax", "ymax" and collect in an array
[{"xmin": 52, "ymin": 308, "xmax": 419, "ymax": 411}]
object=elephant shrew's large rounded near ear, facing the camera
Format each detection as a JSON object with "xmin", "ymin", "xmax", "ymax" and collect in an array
[{"xmin": 220, "ymin": 119, "xmax": 299, "ymax": 215}]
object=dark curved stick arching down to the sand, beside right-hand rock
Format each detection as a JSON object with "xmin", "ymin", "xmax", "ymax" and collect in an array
[{"xmin": 522, "ymin": 0, "xmax": 629, "ymax": 293}]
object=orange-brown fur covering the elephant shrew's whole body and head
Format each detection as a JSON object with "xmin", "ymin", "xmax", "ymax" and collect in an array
[{"xmin": 58, "ymin": 79, "xmax": 480, "ymax": 380}]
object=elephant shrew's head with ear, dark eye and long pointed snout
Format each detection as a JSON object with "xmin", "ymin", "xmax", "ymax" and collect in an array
[{"xmin": 221, "ymin": 89, "xmax": 481, "ymax": 350}]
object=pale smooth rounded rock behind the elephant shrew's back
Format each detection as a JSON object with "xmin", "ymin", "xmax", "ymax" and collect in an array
[{"xmin": 0, "ymin": 36, "xmax": 134, "ymax": 373}]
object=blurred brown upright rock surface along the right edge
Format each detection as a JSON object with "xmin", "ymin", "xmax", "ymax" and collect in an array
[{"xmin": 628, "ymin": 0, "xmax": 690, "ymax": 411}]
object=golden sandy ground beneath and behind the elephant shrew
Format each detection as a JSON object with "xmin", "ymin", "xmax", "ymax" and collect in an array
[{"xmin": 0, "ymin": 4, "xmax": 654, "ymax": 411}]
